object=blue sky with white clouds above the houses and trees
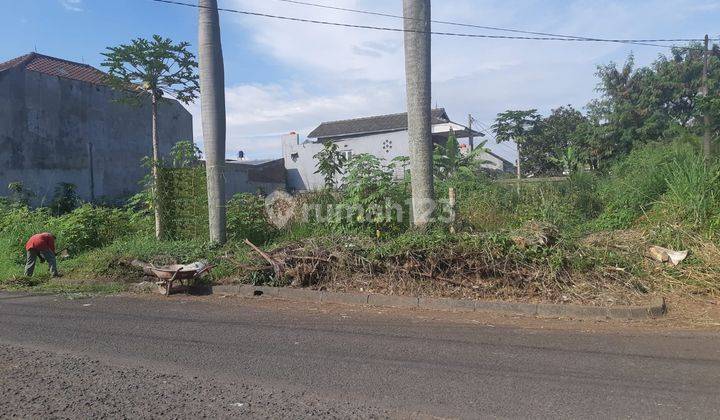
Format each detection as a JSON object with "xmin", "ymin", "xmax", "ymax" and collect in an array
[{"xmin": 0, "ymin": 0, "xmax": 720, "ymax": 160}]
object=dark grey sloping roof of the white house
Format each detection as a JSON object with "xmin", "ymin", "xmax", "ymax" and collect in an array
[{"xmin": 308, "ymin": 108, "xmax": 450, "ymax": 139}]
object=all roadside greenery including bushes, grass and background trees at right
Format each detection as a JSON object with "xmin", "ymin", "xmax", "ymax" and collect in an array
[{"xmin": 0, "ymin": 43, "xmax": 720, "ymax": 305}]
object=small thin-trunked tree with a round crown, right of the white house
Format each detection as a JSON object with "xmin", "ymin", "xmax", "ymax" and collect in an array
[{"xmin": 492, "ymin": 109, "xmax": 542, "ymax": 174}]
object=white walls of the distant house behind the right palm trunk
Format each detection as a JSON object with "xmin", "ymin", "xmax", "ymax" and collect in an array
[{"xmin": 282, "ymin": 108, "xmax": 513, "ymax": 191}]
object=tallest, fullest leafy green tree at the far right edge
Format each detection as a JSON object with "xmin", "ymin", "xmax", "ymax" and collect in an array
[{"xmin": 585, "ymin": 43, "xmax": 720, "ymax": 158}]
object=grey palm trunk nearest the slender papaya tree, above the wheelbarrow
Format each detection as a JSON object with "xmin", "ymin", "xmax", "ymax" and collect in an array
[{"xmin": 198, "ymin": 0, "xmax": 226, "ymax": 244}]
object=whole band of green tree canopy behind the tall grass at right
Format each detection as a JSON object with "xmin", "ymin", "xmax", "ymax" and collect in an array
[{"xmin": 493, "ymin": 43, "xmax": 720, "ymax": 175}]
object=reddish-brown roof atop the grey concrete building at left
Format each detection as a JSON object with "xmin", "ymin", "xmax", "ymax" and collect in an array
[{"xmin": 0, "ymin": 53, "xmax": 105, "ymax": 85}]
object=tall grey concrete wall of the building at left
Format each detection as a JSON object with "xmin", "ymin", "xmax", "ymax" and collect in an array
[{"xmin": 0, "ymin": 68, "xmax": 192, "ymax": 204}]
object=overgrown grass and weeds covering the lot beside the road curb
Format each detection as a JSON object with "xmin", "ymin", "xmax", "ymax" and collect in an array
[{"xmin": 0, "ymin": 138, "xmax": 720, "ymax": 301}]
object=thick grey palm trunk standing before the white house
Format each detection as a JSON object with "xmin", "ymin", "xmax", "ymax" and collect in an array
[{"xmin": 403, "ymin": 0, "xmax": 435, "ymax": 228}]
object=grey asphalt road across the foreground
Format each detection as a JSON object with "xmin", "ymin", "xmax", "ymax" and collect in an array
[{"xmin": 0, "ymin": 294, "xmax": 720, "ymax": 418}]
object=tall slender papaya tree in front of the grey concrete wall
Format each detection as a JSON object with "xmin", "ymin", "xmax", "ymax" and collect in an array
[{"xmin": 102, "ymin": 35, "xmax": 199, "ymax": 239}]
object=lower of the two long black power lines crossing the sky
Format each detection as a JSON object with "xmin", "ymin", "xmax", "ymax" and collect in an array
[{"xmin": 151, "ymin": 0, "xmax": 712, "ymax": 48}]
